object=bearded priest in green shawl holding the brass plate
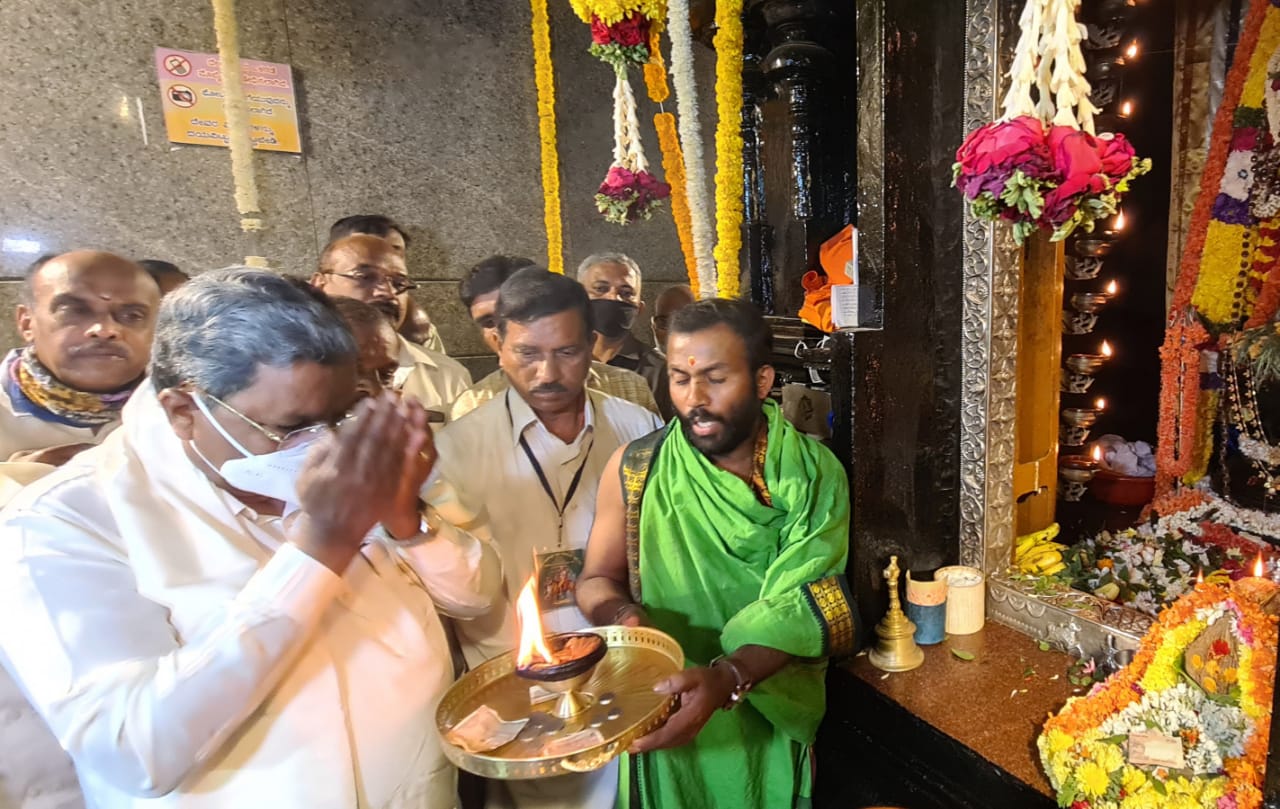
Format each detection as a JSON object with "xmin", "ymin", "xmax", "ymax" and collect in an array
[{"xmin": 577, "ymin": 300, "xmax": 858, "ymax": 809}]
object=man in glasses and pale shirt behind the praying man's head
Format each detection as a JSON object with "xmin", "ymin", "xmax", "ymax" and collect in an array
[{"xmin": 311, "ymin": 234, "xmax": 471, "ymax": 421}]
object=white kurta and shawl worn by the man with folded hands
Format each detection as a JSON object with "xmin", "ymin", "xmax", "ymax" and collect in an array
[{"xmin": 0, "ymin": 388, "xmax": 502, "ymax": 809}]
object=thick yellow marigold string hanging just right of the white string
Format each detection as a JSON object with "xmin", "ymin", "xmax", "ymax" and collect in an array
[{"xmin": 714, "ymin": 0, "xmax": 742, "ymax": 298}]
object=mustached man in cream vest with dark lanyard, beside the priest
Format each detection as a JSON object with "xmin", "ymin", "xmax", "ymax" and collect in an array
[{"xmin": 436, "ymin": 268, "xmax": 662, "ymax": 809}]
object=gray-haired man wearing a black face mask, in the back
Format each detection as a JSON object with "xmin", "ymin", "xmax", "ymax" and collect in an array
[{"xmin": 577, "ymin": 253, "xmax": 675, "ymax": 420}]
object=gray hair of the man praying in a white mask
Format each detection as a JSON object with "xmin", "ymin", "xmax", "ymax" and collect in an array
[{"xmin": 151, "ymin": 266, "xmax": 357, "ymax": 399}]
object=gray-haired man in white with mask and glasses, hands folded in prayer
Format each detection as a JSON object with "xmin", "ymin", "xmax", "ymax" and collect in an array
[{"xmin": 0, "ymin": 269, "xmax": 502, "ymax": 809}]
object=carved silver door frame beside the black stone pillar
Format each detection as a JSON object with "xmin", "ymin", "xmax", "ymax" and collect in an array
[{"xmin": 959, "ymin": 0, "xmax": 1151, "ymax": 657}]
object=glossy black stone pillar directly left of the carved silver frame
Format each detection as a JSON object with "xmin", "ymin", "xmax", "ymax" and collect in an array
[{"xmin": 849, "ymin": 0, "xmax": 965, "ymax": 626}]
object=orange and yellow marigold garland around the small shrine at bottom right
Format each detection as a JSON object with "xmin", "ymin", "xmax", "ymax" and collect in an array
[{"xmin": 1037, "ymin": 579, "xmax": 1277, "ymax": 809}]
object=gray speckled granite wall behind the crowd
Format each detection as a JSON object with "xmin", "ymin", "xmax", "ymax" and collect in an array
[{"xmin": 0, "ymin": 0, "xmax": 714, "ymax": 372}]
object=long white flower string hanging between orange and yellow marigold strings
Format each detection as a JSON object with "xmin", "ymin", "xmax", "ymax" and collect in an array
[{"xmin": 667, "ymin": 0, "xmax": 716, "ymax": 297}]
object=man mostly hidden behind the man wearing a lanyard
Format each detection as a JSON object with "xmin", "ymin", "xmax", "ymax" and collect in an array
[{"xmin": 449, "ymin": 256, "xmax": 658, "ymax": 419}]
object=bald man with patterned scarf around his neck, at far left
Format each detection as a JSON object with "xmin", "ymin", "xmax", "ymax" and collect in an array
[{"xmin": 0, "ymin": 250, "xmax": 160, "ymax": 808}]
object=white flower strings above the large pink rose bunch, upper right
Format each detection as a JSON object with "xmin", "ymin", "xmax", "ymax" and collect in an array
[{"xmin": 1002, "ymin": 0, "xmax": 1098, "ymax": 134}]
